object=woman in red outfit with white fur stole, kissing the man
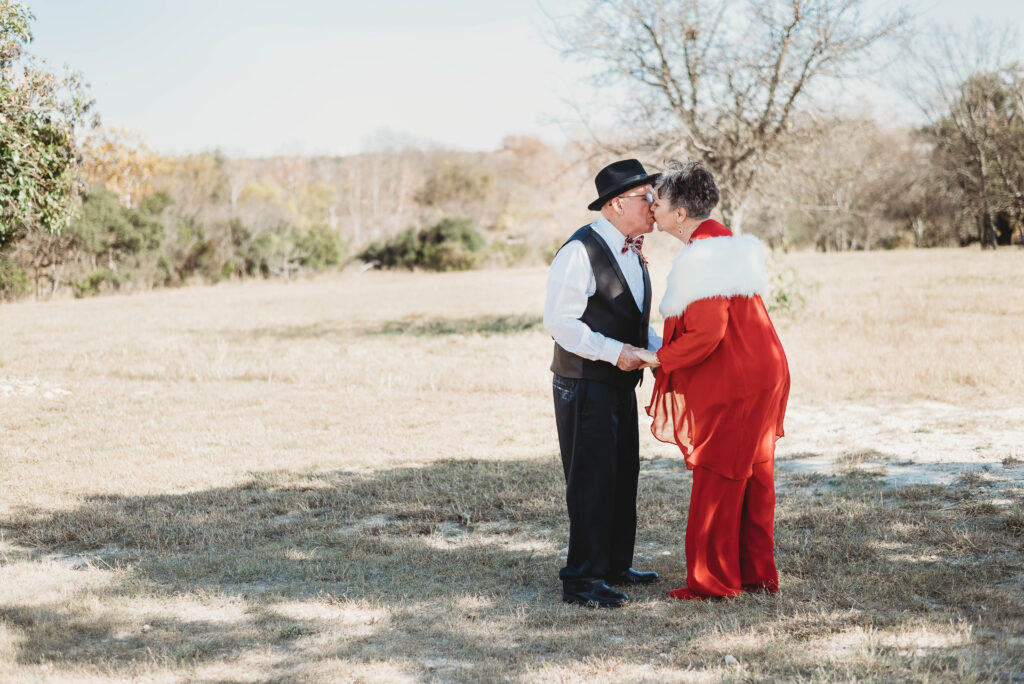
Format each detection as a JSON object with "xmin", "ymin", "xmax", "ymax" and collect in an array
[{"xmin": 647, "ymin": 162, "xmax": 790, "ymax": 600}]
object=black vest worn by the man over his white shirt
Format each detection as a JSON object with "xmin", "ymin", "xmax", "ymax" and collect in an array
[{"xmin": 551, "ymin": 225, "xmax": 650, "ymax": 389}]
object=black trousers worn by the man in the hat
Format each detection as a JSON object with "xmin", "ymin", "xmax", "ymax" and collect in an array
[{"xmin": 552, "ymin": 375, "xmax": 640, "ymax": 582}]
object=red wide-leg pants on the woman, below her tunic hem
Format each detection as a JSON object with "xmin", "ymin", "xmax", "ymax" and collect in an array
[{"xmin": 671, "ymin": 461, "xmax": 778, "ymax": 599}]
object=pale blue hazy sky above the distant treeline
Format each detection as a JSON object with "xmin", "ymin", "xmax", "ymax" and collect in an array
[{"xmin": 22, "ymin": 0, "xmax": 1024, "ymax": 156}]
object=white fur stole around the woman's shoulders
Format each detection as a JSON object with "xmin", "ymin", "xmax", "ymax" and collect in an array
[{"xmin": 659, "ymin": 234, "xmax": 768, "ymax": 318}]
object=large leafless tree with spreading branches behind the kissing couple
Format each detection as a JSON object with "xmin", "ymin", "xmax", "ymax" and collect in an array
[{"xmin": 556, "ymin": 0, "xmax": 907, "ymax": 230}]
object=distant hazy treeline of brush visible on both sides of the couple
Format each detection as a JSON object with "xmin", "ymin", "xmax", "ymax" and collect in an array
[{"xmin": 0, "ymin": 111, "xmax": 1024, "ymax": 298}]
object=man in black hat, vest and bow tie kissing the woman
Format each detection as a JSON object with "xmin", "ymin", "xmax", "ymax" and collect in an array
[{"xmin": 544, "ymin": 159, "xmax": 660, "ymax": 607}]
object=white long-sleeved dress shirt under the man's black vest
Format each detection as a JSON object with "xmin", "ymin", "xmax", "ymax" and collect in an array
[{"xmin": 544, "ymin": 216, "xmax": 662, "ymax": 365}]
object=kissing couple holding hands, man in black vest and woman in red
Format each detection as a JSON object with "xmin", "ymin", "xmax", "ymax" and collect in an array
[{"xmin": 544, "ymin": 159, "xmax": 790, "ymax": 608}]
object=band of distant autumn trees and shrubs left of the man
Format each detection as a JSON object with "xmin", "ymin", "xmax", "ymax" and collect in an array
[{"xmin": 0, "ymin": 131, "xmax": 585, "ymax": 298}]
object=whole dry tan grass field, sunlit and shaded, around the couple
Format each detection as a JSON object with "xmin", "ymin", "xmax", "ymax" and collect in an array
[{"xmin": 0, "ymin": 245, "xmax": 1024, "ymax": 682}]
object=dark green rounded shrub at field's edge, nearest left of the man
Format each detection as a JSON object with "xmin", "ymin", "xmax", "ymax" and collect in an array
[{"xmin": 358, "ymin": 218, "xmax": 485, "ymax": 270}]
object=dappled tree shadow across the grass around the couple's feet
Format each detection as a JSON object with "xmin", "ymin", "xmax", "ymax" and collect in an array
[{"xmin": 0, "ymin": 458, "xmax": 1024, "ymax": 681}]
